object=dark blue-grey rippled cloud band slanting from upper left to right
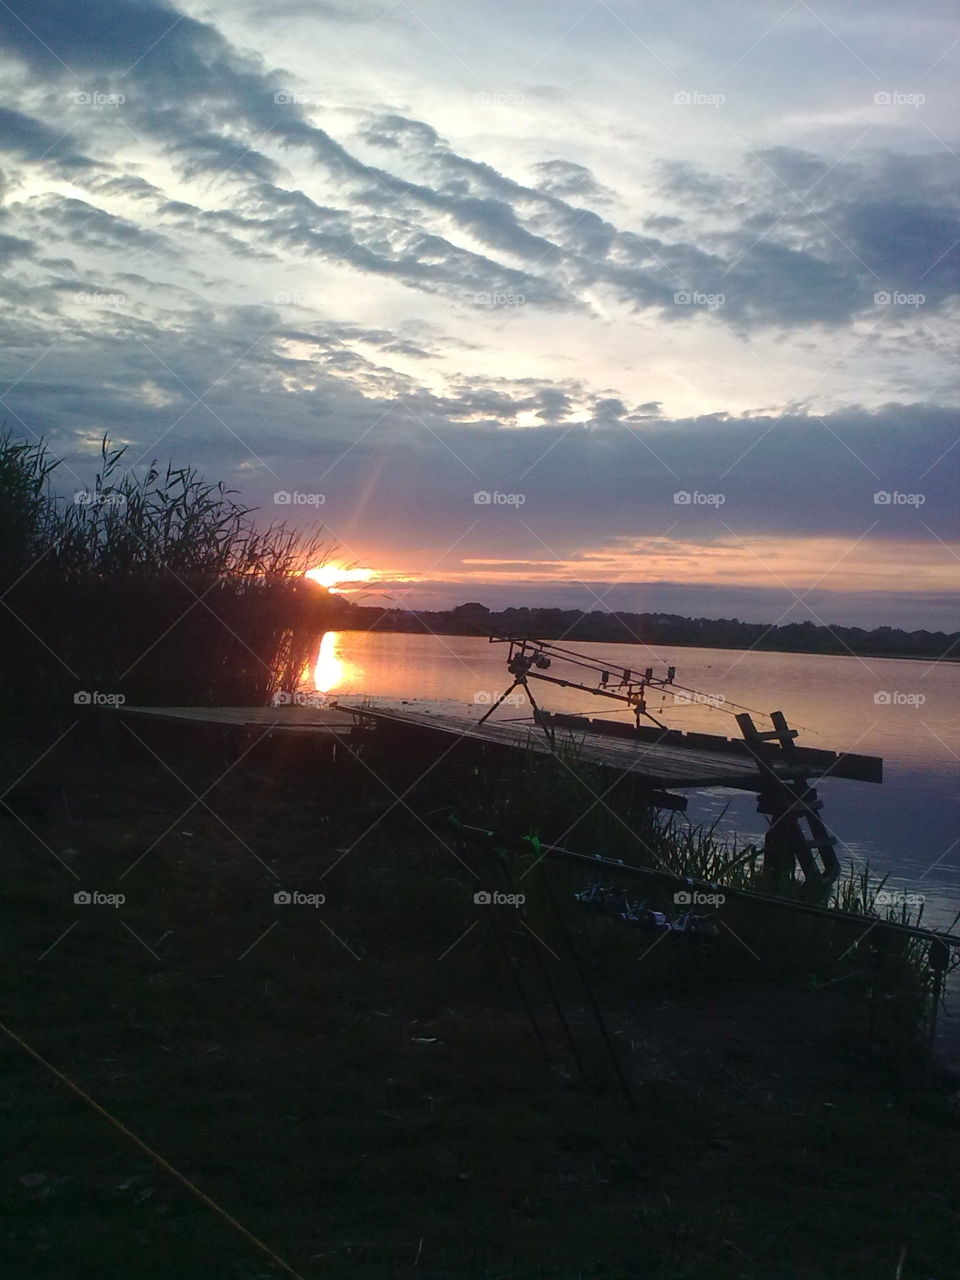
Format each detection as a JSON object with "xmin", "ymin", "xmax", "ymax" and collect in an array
[{"xmin": 0, "ymin": 0, "xmax": 960, "ymax": 334}]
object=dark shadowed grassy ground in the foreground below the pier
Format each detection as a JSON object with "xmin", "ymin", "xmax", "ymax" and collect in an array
[{"xmin": 0, "ymin": 732, "xmax": 960, "ymax": 1280}]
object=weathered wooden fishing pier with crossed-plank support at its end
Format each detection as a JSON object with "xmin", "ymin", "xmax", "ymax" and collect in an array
[{"xmin": 119, "ymin": 691, "xmax": 883, "ymax": 891}]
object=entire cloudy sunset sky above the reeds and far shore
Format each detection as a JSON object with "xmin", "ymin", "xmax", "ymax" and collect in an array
[{"xmin": 0, "ymin": 0, "xmax": 960, "ymax": 630}]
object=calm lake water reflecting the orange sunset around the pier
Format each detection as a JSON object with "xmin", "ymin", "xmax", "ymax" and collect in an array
[{"xmin": 314, "ymin": 631, "xmax": 960, "ymax": 927}]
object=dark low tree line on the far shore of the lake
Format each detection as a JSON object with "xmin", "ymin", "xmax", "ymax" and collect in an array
[{"xmin": 343, "ymin": 603, "xmax": 960, "ymax": 659}]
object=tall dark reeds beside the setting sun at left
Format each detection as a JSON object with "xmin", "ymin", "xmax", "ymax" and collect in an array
[{"xmin": 0, "ymin": 434, "xmax": 334, "ymax": 712}]
